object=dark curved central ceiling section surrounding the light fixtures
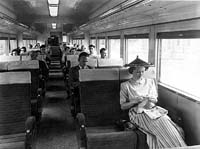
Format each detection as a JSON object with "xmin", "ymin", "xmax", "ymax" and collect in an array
[{"xmin": 3, "ymin": 0, "xmax": 109, "ymax": 33}]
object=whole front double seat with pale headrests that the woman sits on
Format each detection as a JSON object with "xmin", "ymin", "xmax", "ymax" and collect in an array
[{"xmin": 75, "ymin": 68, "xmax": 155, "ymax": 149}]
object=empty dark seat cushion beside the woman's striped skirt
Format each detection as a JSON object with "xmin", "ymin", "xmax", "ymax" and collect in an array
[{"xmin": 86, "ymin": 126, "xmax": 137, "ymax": 149}]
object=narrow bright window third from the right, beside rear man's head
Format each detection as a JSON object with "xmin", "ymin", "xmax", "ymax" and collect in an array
[{"xmin": 108, "ymin": 37, "xmax": 120, "ymax": 58}]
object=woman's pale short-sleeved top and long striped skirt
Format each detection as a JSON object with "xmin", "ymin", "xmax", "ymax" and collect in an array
[{"xmin": 120, "ymin": 78, "xmax": 186, "ymax": 149}]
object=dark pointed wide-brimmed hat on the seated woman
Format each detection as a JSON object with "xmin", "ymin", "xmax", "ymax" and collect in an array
[{"xmin": 125, "ymin": 56, "xmax": 153, "ymax": 73}]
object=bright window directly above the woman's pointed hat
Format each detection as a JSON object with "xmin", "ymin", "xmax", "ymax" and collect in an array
[{"xmin": 125, "ymin": 34, "xmax": 149, "ymax": 63}]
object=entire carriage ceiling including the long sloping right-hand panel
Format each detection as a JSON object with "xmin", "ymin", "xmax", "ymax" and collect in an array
[{"xmin": 0, "ymin": 0, "xmax": 200, "ymax": 34}]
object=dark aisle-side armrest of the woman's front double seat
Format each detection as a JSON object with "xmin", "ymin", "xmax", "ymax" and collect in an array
[{"xmin": 76, "ymin": 113, "xmax": 87, "ymax": 148}]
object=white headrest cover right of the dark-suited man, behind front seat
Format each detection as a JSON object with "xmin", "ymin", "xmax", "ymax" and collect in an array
[{"xmin": 97, "ymin": 58, "xmax": 123, "ymax": 68}]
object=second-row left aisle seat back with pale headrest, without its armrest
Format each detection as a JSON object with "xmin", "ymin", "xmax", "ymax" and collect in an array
[{"xmin": 8, "ymin": 60, "xmax": 39, "ymax": 99}]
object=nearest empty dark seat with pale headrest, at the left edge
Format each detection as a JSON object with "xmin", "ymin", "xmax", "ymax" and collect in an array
[{"xmin": 0, "ymin": 71, "xmax": 37, "ymax": 149}]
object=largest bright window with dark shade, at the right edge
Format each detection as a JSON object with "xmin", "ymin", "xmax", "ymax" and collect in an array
[{"xmin": 158, "ymin": 31, "xmax": 200, "ymax": 97}]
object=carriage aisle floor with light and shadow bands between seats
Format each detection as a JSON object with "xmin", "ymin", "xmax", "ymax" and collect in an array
[{"xmin": 33, "ymin": 61, "xmax": 78, "ymax": 149}]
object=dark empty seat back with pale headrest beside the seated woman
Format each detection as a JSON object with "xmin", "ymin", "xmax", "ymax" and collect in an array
[{"xmin": 79, "ymin": 69, "xmax": 121, "ymax": 126}]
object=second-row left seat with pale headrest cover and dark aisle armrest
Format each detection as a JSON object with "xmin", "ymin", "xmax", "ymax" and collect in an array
[{"xmin": 0, "ymin": 60, "xmax": 45, "ymax": 121}]
